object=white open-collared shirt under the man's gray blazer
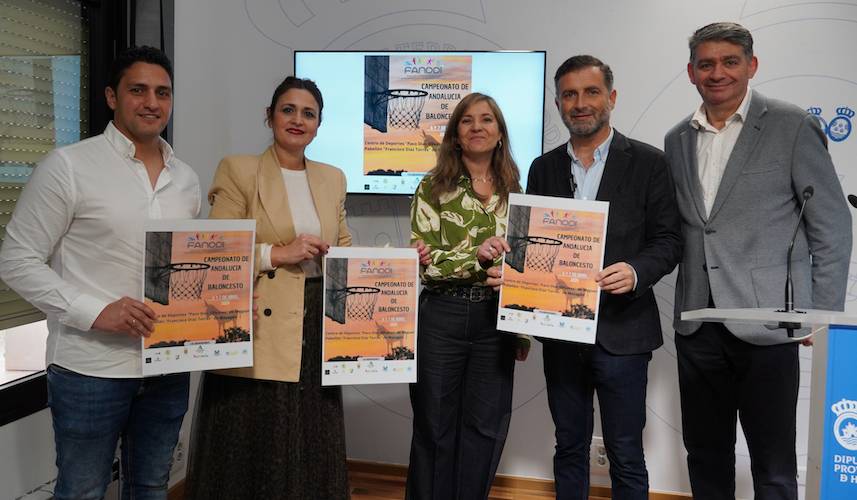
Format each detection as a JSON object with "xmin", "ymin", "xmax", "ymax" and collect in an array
[{"xmin": 690, "ymin": 89, "xmax": 751, "ymax": 215}]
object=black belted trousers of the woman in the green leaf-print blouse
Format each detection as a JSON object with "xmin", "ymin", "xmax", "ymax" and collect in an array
[{"xmin": 406, "ymin": 291, "xmax": 515, "ymax": 500}]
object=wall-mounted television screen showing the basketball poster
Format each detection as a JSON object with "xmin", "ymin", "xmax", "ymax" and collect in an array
[{"xmin": 295, "ymin": 51, "xmax": 545, "ymax": 195}]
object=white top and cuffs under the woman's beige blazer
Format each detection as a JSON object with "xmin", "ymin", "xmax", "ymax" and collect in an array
[{"xmin": 259, "ymin": 168, "xmax": 321, "ymax": 278}]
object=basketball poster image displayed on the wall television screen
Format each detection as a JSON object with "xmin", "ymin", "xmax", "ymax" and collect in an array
[{"xmin": 363, "ymin": 54, "xmax": 472, "ymax": 176}]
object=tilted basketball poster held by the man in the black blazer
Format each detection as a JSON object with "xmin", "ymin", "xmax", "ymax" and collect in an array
[{"xmin": 497, "ymin": 194, "xmax": 609, "ymax": 344}]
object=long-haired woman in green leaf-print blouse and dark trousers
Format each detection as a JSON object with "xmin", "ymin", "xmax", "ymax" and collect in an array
[{"xmin": 407, "ymin": 93, "xmax": 529, "ymax": 500}]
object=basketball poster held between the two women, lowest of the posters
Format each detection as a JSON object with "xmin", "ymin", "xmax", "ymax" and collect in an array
[{"xmin": 321, "ymin": 247, "xmax": 419, "ymax": 385}]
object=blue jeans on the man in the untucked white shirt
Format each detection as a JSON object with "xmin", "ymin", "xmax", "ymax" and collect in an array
[{"xmin": 47, "ymin": 365, "xmax": 190, "ymax": 500}]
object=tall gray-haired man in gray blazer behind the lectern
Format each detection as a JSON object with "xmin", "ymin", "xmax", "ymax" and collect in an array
[{"xmin": 665, "ymin": 23, "xmax": 851, "ymax": 500}]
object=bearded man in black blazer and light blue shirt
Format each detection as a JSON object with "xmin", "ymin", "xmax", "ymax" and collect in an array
[{"xmin": 527, "ymin": 56, "xmax": 682, "ymax": 499}]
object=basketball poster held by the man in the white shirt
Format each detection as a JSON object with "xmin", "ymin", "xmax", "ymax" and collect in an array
[{"xmin": 142, "ymin": 220, "xmax": 256, "ymax": 376}]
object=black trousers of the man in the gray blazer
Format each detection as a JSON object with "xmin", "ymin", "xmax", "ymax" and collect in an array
[{"xmin": 675, "ymin": 323, "xmax": 800, "ymax": 500}]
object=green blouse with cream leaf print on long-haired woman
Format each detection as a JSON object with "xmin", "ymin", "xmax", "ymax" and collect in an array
[{"xmin": 411, "ymin": 175, "xmax": 509, "ymax": 286}]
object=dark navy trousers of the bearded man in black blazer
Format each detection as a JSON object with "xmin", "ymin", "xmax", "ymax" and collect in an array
[{"xmin": 542, "ymin": 340, "xmax": 652, "ymax": 500}]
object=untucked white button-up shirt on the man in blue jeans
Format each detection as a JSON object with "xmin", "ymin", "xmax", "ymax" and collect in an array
[{"xmin": 0, "ymin": 122, "xmax": 200, "ymax": 378}]
